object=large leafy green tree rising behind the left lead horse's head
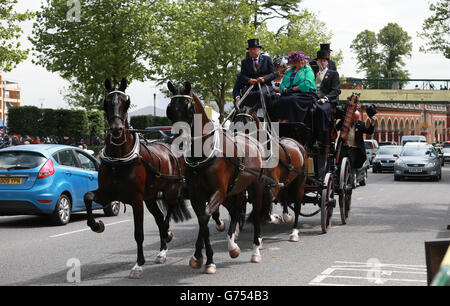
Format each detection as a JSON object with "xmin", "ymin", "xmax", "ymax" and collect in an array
[{"xmin": 30, "ymin": 0, "xmax": 163, "ymax": 109}]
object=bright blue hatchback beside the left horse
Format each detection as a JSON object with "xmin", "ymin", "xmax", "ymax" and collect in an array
[{"xmin": 0, "ymin": 145, "xmax": 120, "ymax": 225}]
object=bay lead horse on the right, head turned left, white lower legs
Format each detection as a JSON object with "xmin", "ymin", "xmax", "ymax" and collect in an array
[{"xmin": 167, "ymin": 82, "xmax": 264, "ymax": 274}]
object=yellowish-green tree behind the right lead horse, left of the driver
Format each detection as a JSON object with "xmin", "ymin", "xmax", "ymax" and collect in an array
[{"xmin": 153, "ymin": 0, "xmax": 254, "ymax": 120}]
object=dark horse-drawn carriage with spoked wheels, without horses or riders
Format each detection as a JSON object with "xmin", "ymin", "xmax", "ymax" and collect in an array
[{"xmin": 229, "ymin": 86, "xmax": 359, "ymax": 233}]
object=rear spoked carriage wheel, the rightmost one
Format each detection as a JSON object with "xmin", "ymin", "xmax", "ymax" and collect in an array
[{"xmin": 339, "ymin": 157, "xmax": 353, "ymax": 224}]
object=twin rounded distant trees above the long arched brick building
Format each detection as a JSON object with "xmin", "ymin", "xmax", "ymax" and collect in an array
[{"xmin": 351, "ymin": 23, "xmax": 412, "ymax": 86}]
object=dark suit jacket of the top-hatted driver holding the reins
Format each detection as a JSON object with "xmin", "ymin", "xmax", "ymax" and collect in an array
[{"xmin": 241, "ymin": 54, "xmax": 275, "ymax": 87}]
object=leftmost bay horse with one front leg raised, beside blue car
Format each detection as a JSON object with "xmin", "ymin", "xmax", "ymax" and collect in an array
[{"xmin": 84, "ymin": 79, "xmax": 190, "ymax": 278}]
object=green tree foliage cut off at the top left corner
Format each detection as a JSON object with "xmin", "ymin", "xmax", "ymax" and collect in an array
[{"xmin": 0, "ymin": 0, "xmax": 32, "ymax": 72}]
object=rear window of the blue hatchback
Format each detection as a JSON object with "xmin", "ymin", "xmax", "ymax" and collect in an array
[{"xmin": 0, "ymin": 151, "xmax": 47, "ymax": 170}]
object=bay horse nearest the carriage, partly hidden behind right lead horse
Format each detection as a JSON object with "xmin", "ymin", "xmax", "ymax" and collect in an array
[{"xmin": 233, "ymin": 105, "xmax": 308, "ymax": 242}]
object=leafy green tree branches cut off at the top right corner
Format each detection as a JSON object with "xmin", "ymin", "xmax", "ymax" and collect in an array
[{"xmin": 419, "ymin": 0, "xmax": 450, "ymax": 59}]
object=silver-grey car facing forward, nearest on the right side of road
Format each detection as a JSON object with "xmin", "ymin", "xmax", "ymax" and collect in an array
[{"xmin": 394, "ymin": 143, "xmax": 442, "ymax": 181}]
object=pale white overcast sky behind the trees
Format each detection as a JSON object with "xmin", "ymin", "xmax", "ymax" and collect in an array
[{"xmin": 5, "ymin": 0, "xmax": 450, "ymax": 111}]
